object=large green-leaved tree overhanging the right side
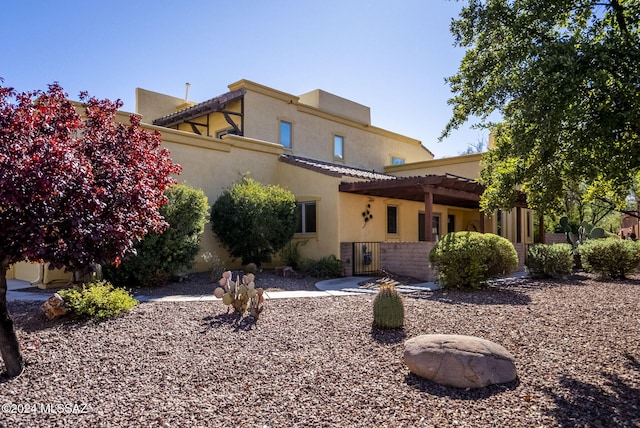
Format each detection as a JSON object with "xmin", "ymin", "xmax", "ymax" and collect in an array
[{"xmin": 442, "ymin": 0, "xmax": 640, "ymax": 211}]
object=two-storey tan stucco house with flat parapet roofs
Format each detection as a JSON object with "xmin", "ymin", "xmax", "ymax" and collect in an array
[{"xmin": 7, "ymin": 80, "xmax": 533, "ymax": 282}]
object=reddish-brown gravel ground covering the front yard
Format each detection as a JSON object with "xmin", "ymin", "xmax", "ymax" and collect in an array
[{"xmin": 0, "ymin": 274, "xmax": 640, "ymax": 428}]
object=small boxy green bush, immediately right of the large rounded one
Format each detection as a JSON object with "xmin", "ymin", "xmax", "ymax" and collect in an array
[{"xmin": 526, "ymin": 244, "xmax": 574, "ymax": 278}]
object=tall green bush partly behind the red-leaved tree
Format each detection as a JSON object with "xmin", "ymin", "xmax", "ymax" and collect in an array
[{"xmin": 103, "ymin": 184, "xmax": 209, "ymax": 287}]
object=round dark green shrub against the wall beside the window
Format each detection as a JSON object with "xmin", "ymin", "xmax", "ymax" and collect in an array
[{"xmin": 211, "ymin": 177, "xmax": 296, "ymax": 266}]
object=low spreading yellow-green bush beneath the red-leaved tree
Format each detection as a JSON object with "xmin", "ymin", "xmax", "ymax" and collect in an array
[{"xmin": 58, "ymin": 281, "xmax": 139, "ymax": 319}]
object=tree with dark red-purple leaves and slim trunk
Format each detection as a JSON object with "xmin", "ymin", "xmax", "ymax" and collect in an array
[{"xmin": 0, "ymin": 80, "xmax": 181, "ymax": 377}]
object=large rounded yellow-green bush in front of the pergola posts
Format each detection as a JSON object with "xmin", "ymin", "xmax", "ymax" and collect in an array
[{"xmin": 429, "ymin": 232, "xmax": 518, "ymax": 289}]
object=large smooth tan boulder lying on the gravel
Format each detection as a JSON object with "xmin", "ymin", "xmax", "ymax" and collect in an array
[{"xmin": 404, "ymin": 334, "xmax": 517, "ymax": 388}]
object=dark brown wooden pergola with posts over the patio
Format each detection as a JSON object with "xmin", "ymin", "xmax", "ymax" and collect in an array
[{"xmin": 339, "ymin": 174, "xmax": 526, "ymax": 241}]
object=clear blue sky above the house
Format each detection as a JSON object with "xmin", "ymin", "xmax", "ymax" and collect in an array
[{"xmin": 0, "ymin": 0, "xmax": 488, "ymax": 158}]
